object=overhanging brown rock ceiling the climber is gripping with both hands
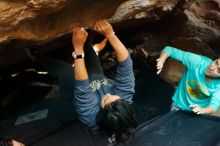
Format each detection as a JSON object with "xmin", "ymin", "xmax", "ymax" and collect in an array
[{"xmin": 0, "ymin": 0, "xmax": 177, "ymax": 67}]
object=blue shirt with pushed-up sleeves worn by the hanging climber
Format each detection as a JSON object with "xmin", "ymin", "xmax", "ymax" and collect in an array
[{"xmin": 74, "ymin": 56, "xmax": 135, "ymax": 127}]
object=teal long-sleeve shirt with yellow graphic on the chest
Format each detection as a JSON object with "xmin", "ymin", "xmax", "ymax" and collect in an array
[{"xmin": 163, "ymin": 46, "xmax": 220, "ymax": 112}]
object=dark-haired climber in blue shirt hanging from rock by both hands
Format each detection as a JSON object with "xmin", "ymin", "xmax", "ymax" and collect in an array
[{"xmin": 72, "ymin": 20, "xmax": 136, "ymax": 142}]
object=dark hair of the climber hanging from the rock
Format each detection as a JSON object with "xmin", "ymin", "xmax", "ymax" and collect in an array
[{"xmin": 96, "ymin": 99, "xmax": 137, "ymax": 142}]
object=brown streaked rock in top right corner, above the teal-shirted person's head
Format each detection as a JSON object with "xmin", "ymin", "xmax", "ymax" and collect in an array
[{"xmin": 184, "ymin": 0, "xmax": 220, "ymax": 41}]
